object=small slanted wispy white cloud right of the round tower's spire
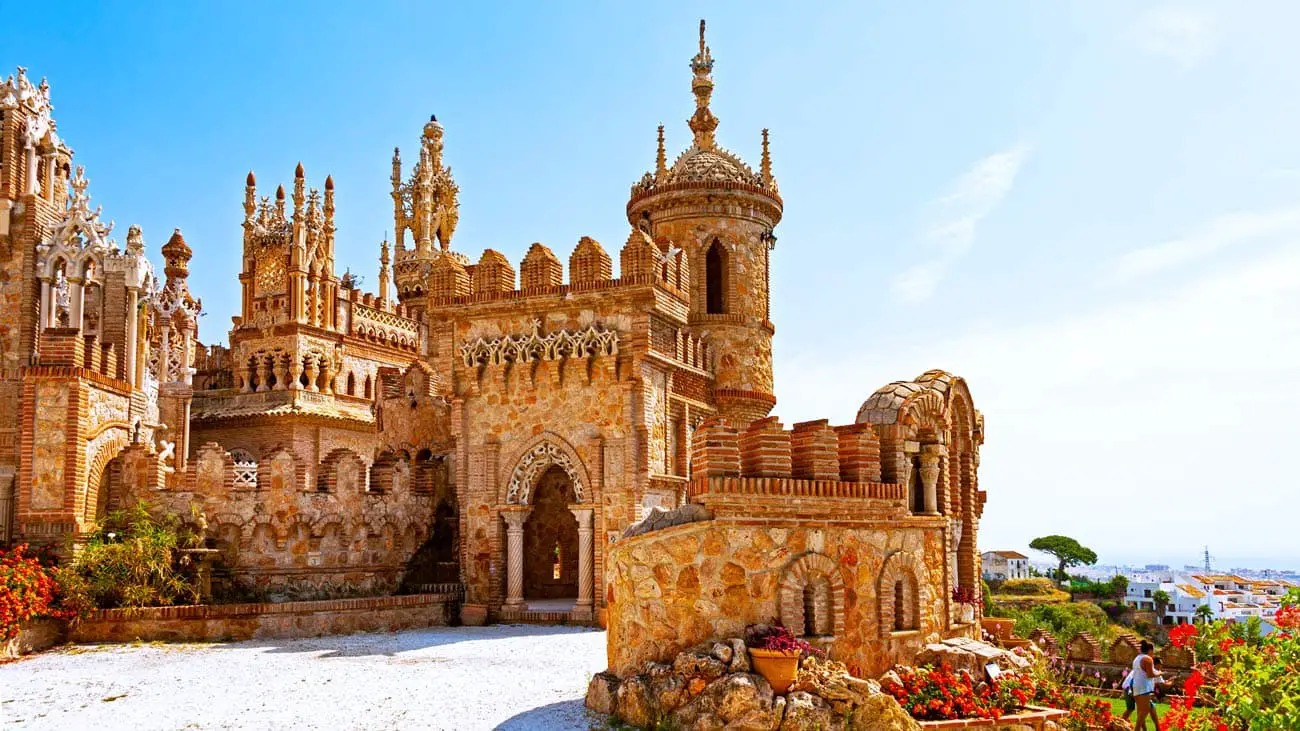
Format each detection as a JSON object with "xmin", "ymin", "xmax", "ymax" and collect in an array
[{"xmin": 893, "ymin": 144, "xmax": 1028, "ymax": 303}]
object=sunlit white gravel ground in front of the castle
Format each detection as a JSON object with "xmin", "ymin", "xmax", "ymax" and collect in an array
[{"xmin": 0, "ymin": 626, "xmax": 606, "ymax": 731}]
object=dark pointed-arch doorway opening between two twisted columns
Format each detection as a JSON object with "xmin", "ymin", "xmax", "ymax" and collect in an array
[{"xmin": 524, "ymin": 466, "xmax": 579, "ymax": 600}]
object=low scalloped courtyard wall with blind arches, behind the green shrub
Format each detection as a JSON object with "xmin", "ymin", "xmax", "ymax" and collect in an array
[{"xmin": 105, "ymin": 444, "xmax": 446, "ymax": 597}]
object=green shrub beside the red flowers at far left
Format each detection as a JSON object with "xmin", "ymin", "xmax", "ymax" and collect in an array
[{"xmin": 59, "ymin": 502, "xmax": 202, "ymax": 609}]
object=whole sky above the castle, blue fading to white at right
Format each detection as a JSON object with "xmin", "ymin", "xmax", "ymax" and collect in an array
[{"xmin": 0, "ymin": 0, "xmax": 1300, "ymax": 566}]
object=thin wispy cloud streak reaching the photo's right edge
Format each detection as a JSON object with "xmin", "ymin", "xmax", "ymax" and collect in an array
[{"xmin": 1110, "ymin": 207, "xmax": 1300, "ymax": 282}]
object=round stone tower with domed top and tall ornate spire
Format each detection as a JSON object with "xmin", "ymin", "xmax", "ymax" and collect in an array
[{"xmin": 628, "ymin": 21, "xmax": 783, "ymax": 429}]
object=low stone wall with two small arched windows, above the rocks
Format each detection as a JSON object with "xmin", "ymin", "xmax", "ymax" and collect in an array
[{"xmin": 605, "ymin": 519, "xmax": 948, "ymax": 676}]
